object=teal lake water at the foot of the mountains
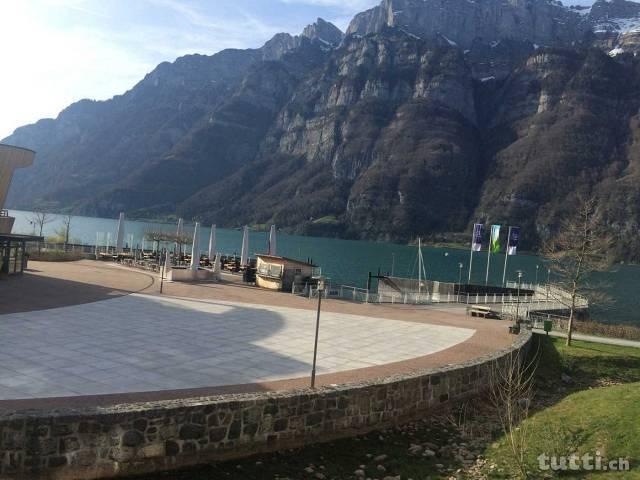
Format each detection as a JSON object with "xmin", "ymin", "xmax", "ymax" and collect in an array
[{"xmin": 10, "ymin": 210, "xmax": 640, "ymax": 324}]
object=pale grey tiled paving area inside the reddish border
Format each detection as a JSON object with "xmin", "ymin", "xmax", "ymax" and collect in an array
[{"xmin": 0, "ymin": 294, "xmax": 475, "ymax": 400}]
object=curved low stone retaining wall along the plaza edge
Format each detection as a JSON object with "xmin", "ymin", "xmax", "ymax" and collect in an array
[{"xmin": 0, "ymin": 332, "xmax": 531, "ymax": 480}]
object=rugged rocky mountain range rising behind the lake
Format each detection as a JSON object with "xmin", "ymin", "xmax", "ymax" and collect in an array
[{"xmin": 4, "ymin": 0, "xmax": 640, "ymax": 259}]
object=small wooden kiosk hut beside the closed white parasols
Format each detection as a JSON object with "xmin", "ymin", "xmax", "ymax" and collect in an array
[{"xmin": 256, "ymin": 255, "xmax": 319, "ymax": 291}]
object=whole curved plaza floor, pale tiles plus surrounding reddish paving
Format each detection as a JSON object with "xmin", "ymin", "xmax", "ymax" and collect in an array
[{"xmin": 0, "ymin": 260, "xmax": 514, "ymax": 410}]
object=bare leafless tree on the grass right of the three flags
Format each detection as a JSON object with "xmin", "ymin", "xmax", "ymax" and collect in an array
[{"xmin": 544, "ymin": 198, "xmax": 612, "ymax": 346}]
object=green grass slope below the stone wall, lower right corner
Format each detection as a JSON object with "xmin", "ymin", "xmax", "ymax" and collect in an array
[{"xmin": 486, "ymin": 337, "xmax": 640, "ymax": 479}]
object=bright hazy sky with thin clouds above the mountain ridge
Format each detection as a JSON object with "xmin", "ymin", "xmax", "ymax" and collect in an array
[{"xmin": 0, "ymin": 0, "xmax": 592, "ymax": 139}]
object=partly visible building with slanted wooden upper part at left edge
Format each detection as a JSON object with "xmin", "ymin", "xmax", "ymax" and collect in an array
[{"xmin": 0, "ymin": 144, "xmax": 42, "ymax": 275}]
